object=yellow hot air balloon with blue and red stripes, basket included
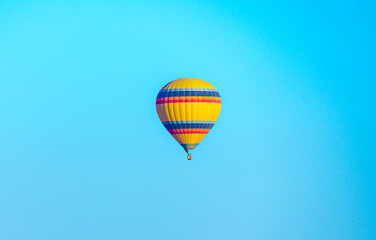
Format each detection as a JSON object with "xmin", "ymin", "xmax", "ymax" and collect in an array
[{"xmin": 156, "ymin": 78, "xmax": 222, "ymax": 160}]
